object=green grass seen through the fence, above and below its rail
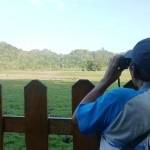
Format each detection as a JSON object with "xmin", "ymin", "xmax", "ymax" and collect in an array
[{"xmin": 0, "ymin": 80, "xmax": 128, "ymax": 150}]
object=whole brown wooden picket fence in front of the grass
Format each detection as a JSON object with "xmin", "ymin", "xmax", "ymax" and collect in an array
[{"xmin": 0, "ymin": 80, "xmax": 100, "ymax": 150}]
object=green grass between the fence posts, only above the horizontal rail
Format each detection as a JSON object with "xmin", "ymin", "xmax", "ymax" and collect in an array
[{"xmin": 1, "ymin": 80, "xmax": 74, "ymax": 117}]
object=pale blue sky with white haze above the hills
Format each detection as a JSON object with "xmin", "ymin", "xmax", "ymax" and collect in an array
[{"xmin": 0, "ymin": 0, "xmax": 150, "ymax": 53}]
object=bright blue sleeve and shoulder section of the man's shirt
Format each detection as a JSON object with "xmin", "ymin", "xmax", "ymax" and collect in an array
[{"xmin": 76, "ymin": 87, "xmax": 148, "ymax": 149}]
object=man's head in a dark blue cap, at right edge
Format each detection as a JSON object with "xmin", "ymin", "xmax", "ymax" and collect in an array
[{"xmin": 127, "ymin": 38, "xmax": 150, "ymax": 87}]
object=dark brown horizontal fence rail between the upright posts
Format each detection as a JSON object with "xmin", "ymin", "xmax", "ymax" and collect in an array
[{"xmin": 3, "ymin": 116, "xmax": 72, "ymax": 135}]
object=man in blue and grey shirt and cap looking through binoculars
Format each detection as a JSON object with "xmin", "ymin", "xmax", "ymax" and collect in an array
[{"xmin": 73, "ymin": 38, "xmax": 150, "ymax": 150}]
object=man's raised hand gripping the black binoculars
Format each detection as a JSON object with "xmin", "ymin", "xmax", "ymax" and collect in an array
[{"xmin": 102, "ymin": 55, "xmax": 123, "ymax": 85}]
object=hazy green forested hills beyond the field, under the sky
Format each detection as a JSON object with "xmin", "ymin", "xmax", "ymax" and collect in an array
[{"xmin": 0, "ymin": 42, "xmax": 113, "ymax": 71}]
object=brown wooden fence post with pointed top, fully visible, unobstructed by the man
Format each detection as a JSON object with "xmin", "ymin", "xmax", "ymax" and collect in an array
[{"xmin": 24, "ymin": 80, "xmax": 48, "ymax": 150}]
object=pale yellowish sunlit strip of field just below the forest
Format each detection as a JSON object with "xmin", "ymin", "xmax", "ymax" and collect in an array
[{"xmin": 0, "ymin": 71, "xmax": 130, "ymax": 81}]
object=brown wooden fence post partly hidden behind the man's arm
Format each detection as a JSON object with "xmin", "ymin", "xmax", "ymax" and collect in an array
[{"xmin": 72, "ymin": 80, "xmax": 100, "ymax": 150}]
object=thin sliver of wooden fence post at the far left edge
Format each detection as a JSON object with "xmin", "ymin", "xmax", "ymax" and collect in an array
[{"xmin": 0, "ymin": 85, "xmax": 3, "ymax": 150}]
